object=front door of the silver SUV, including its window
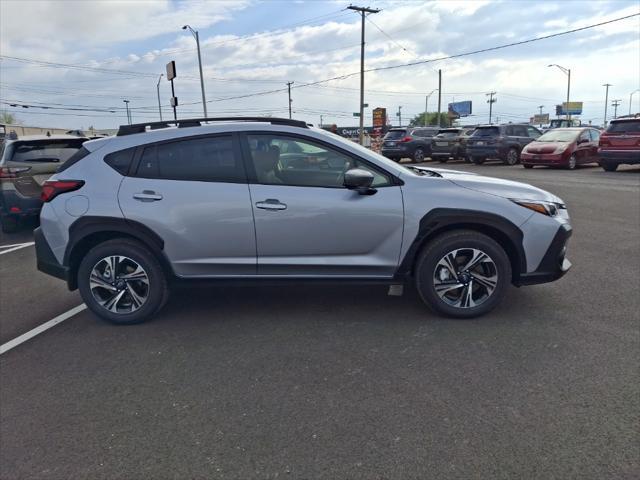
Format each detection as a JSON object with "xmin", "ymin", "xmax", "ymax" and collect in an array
[{"xmin": 243, "ymin": 133, "xmax": 404, "ymax": 278}]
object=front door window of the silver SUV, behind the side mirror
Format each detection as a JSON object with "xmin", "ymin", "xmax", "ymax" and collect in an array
[{"xmin": 247, "ymin": 134, "xmax": 391, "ymax": 188}]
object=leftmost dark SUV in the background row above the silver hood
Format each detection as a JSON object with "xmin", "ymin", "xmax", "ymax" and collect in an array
[{"xmin": 382, "ymin": 127, "xmax": 439, "ymax": 162}]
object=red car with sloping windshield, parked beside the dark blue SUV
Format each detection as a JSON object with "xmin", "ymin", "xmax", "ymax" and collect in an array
[{"xmin": 520, "ymin": 128, "xmax": 600, "ymax": 170}]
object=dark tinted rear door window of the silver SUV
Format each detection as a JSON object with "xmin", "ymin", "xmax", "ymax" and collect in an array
[{"xmin": 136, "ymin": 136, "xmax": 247, "ymax": 183}]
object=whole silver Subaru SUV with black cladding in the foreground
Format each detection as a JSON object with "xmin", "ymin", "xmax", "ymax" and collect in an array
[{"xmin": 35, "ymin": 117, "xmax": 571, "ymax": 324}]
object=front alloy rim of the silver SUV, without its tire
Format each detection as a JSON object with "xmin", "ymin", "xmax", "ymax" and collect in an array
[{"xmin": 433, "ymin": 248, "xmax": 498, "ymax": 308}]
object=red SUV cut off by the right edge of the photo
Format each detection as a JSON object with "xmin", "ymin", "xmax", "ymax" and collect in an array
[{"xmin": 598, "ymin": 116, "xmax": 640, "ymax": 172}]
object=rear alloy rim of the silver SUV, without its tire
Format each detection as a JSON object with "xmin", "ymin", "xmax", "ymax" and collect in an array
[{"xmin": 89, "ymin": 255, "xmax": 149, "ymax": 314}]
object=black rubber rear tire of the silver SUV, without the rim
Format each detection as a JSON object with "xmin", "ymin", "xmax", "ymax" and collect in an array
[{"xmin": 78, "ymin": 238, "xmax": 169, "ymax": 325}]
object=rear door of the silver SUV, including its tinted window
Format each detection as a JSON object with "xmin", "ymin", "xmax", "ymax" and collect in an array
[{"xmin": 118, "ymin": 135, "xmax": 256, "ymax": 277}]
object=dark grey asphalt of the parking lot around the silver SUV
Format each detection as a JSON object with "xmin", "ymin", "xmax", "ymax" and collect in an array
[{"xmin": 0, "ymin": 162, "xmax": 640, "ymax": 479}]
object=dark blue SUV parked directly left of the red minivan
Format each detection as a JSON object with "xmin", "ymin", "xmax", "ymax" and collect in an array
[{"xmin": 467, "ymin": 124, "xmax": 542, "ymax": 165}]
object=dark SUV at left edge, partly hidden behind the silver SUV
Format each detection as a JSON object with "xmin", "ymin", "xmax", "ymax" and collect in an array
[{"xmin": 0, "ymin": 135, "xmax": 87, "ymax": 233}]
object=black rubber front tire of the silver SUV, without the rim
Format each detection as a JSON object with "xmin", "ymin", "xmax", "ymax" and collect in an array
[{"xmin": 415, "ymin": 230, "xmax": 511, "ymax": 318}]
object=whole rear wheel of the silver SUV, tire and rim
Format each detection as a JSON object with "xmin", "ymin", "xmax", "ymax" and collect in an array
[{"xmin": 78, "ymin": 239, "xmax": 169, "ymax": 325}]
